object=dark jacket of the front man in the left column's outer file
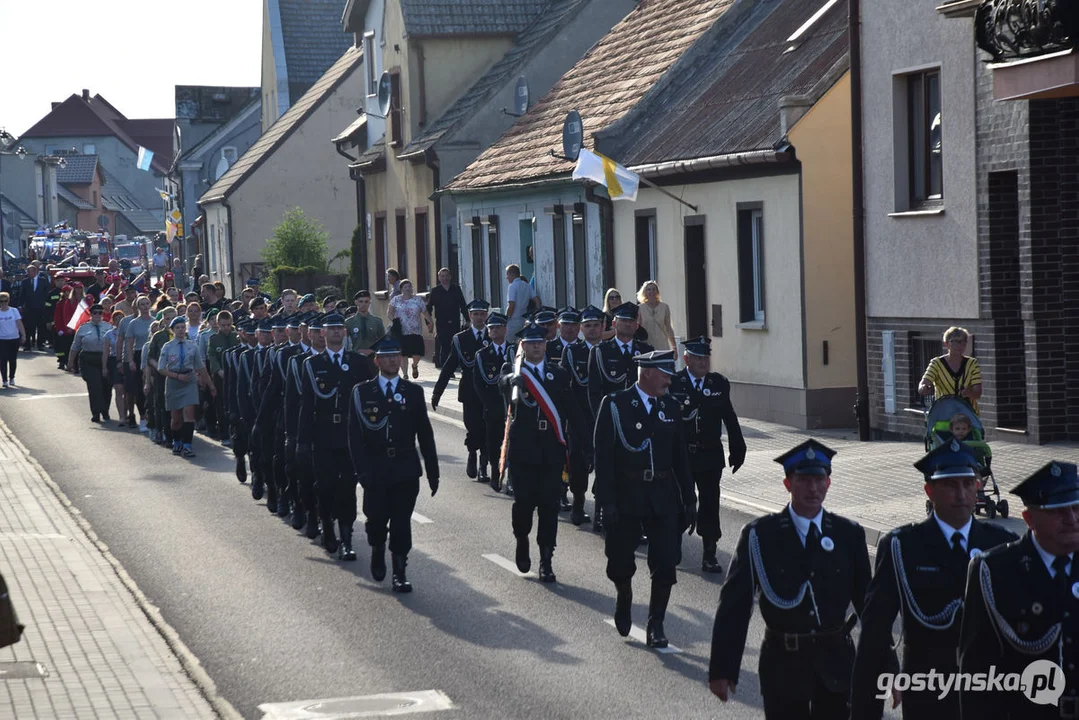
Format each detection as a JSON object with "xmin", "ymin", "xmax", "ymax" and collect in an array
[{"xmin": 296, "ymin": 351, "xmax": 374, "ymax": 453}]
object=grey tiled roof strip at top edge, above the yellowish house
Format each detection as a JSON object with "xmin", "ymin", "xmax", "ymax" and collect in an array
[{"xmin": 400, "ymin": 0, "xmax": 551, "ymax": 36}]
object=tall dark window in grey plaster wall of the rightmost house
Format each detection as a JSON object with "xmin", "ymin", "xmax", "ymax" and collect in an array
[{"xmin": 906, "ymin": 70, "xmax": 944, "ymax": 209}]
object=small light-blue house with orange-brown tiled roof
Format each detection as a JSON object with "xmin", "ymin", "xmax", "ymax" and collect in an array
[{"xmin": 446, "ymin": 0, "xmax": 734, "ymax": 315}]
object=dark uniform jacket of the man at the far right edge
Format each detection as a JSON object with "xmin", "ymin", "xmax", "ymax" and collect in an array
[{"xmin": 959, "ymin": 530, "xmax": 1079, "ymax": 720}]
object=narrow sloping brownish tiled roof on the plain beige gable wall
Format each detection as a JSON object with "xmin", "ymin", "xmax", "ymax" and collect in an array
[{"xmin": 199, "ymin": 47, "xmax": 364, "ymax": 203}]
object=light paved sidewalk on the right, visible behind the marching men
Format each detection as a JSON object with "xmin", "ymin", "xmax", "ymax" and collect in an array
[{"xmin": 418, "ymin": 362, "xmax": 1079, "ymax": 544}]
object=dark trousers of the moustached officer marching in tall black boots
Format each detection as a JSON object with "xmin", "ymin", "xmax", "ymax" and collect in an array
[{"xmin": 603, "ymin": 513, "xmax": 682, "ymax": 585}]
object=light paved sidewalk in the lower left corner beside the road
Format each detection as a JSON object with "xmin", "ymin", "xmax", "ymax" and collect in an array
[{"xmin": 0, "ymin": 414, "xmax": 222, "ymax": 720}]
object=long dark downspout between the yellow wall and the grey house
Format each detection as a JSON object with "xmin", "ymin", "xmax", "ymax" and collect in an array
[{"xmin": 848, "ymin": 0, "xmax": 871, "ymax": 443}]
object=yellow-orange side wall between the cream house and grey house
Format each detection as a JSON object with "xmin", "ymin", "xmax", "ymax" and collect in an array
[{"xmin": 788, "ymin": 73, "xmax": 857, "ymax": 390}]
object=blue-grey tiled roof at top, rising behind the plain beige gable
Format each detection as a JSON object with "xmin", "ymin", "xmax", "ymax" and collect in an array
[{"xmin": 277, "ymin": 0, "xmax": 353, "ymax": 97}]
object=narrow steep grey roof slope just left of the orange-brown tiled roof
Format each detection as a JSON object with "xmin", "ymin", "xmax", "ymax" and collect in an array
[{"xmin": 401, "ymin": 0, "xmax": 602, "ymax": 155}]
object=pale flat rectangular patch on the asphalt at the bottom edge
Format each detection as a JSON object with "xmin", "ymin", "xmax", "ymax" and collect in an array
[{"xmin": 259, "ymin": 690, "xmax": 455, "ymax": 720}]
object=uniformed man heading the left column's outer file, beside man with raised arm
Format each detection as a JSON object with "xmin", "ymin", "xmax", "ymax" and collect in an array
[{"xmin": 296, "ymin": 312, "xmax": 374, "ymax": 560}]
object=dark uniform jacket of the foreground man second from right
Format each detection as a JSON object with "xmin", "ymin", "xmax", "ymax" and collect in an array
[{"xmin": 851, "ymin": 516, "xmax": 1017, "ymax": 720}]
